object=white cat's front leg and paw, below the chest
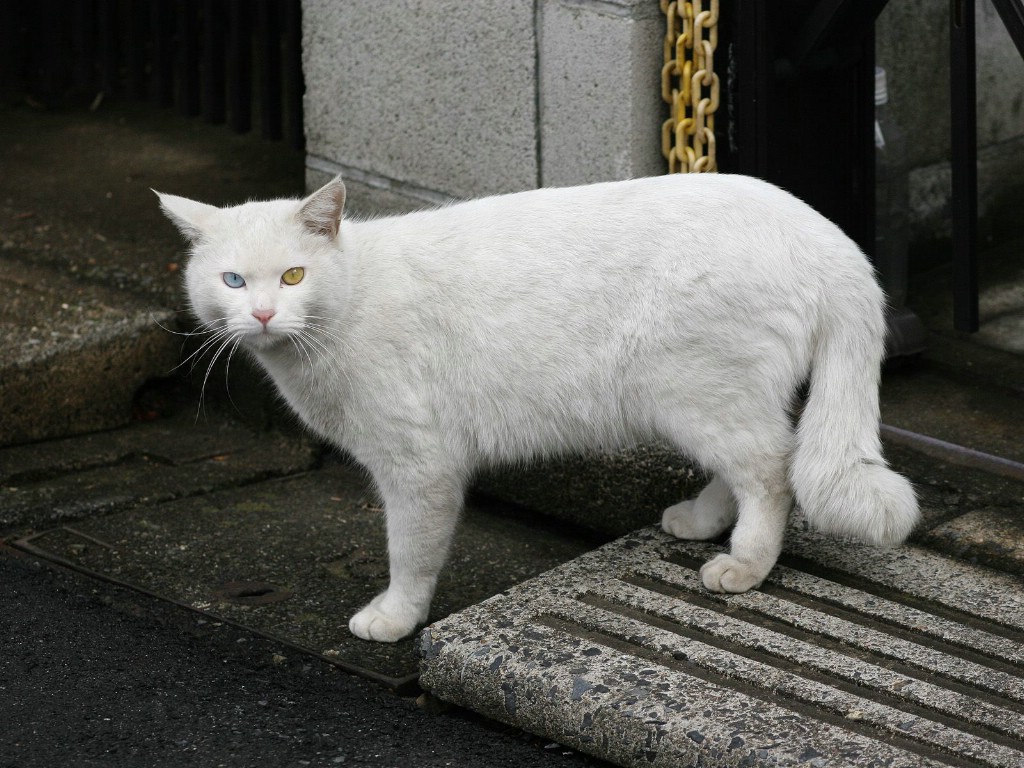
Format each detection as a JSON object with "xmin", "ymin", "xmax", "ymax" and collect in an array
[{"xmin": 348, "ymin": 477, "xmax": 464, "ymax": 643}]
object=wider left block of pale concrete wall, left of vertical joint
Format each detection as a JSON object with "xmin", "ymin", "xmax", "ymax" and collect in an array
[{"xmin": 302, "ymin": 0, "xmax": 538, "ymax": 198}]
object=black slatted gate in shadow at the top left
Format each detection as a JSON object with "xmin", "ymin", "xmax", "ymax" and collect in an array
[{"xmin": 0, "ymin": 0, "xmax": 303, "ymax": 147}]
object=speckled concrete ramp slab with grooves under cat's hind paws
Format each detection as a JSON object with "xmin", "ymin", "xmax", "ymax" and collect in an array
[{"xmin": 420, "ymin": 524, "xmax": 1024, "ymax": 767}]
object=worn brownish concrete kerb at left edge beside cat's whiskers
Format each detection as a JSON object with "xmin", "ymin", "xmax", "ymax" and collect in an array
[{"xmin": 0, "ymin": 256, "xmax": 178, "ymax": 445}]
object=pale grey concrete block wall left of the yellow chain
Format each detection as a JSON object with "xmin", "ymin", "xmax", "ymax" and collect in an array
[{"xmin": 303, "ymin": 0, "xmax": 665, "ymax": 207}]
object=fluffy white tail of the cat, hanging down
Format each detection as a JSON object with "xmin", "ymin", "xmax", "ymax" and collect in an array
[{"xmin": 790, "ymin": 301, "xmax": 920, "ymax": 546}]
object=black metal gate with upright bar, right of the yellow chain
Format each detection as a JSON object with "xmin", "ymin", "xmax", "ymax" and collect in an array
[{"xmin": 718, "ymin": 0, "xmax": 1024, "ymax": 331}]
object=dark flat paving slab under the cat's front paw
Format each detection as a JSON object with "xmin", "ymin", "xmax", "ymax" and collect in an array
[{"xmin": 14, "ymin": 464, "xmax": 595, "ymax": 687}]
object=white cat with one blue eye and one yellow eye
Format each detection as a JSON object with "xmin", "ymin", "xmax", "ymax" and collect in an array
[{"xmin": 160, "ymin": 174, "xmax": 919, "ymax": 641}]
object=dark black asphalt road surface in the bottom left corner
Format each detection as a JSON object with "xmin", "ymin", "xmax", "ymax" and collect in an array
[{"xmin": 0, "ymin": 547, "xmax": 600, "ymax": 768}]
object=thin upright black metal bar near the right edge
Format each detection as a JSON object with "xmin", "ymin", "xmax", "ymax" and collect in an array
[{"xmin": 949, "ymin": 0, "xmax": 979, "ymax": 333}]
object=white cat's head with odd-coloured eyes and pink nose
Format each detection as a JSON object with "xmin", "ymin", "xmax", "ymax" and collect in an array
[{"xmin": 157, "ymin": 177, "xmax": 345, "ymax": 349}]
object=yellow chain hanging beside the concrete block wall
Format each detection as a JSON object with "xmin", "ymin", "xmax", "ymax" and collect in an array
[{"xmin": 660, "ymin": 0, "xmax": 719, "ymax": 173}]
